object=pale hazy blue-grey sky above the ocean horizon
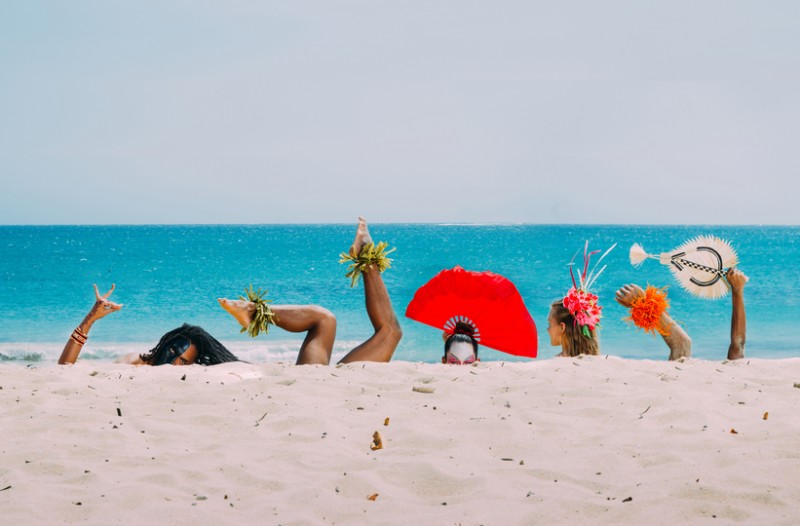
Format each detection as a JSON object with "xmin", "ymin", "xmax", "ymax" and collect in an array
[{"xmin": 0, "ymin": 0, "xmax": 800, "ymax": 224}]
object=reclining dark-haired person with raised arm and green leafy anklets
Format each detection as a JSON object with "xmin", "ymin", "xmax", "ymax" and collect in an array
[{"xmin": 58, "ymin": 218, "xmax": 402, "ymax": 365}]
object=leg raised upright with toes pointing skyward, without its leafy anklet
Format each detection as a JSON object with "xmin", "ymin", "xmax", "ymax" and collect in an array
[{"xmin": 340, "ymin": 217, "xmax": 403, "ymax": 363}]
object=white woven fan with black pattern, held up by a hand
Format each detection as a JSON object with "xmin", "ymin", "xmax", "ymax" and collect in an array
[{"xmin": 630, "ymin": 236, "xmax": 739, "ymax": 299}]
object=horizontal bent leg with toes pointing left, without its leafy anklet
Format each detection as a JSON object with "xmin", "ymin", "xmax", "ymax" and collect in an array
[{"xmin": 217, "ymin": 298, "xmax": 336, "ymax": 365}]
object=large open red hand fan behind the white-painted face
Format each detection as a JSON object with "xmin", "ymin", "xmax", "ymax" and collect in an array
[{"xmin": 406, "ymin": 267, "xmax": 538, "ymax": 358}]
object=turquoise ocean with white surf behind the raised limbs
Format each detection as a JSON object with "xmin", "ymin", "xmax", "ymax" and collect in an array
[{"xmin": 0, "ymin": 224, "xmax": 800, "ymax": 364}]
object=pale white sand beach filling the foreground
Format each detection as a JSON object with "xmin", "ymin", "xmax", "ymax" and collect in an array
[{"xmin": 0, "ymin": 356, "xmax": 800, "ymax": 525}]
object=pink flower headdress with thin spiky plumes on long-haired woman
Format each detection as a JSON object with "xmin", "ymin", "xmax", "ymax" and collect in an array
[{"xmin": 562, "ymin": 241, "xmax": 617, "ymax": 338}]
